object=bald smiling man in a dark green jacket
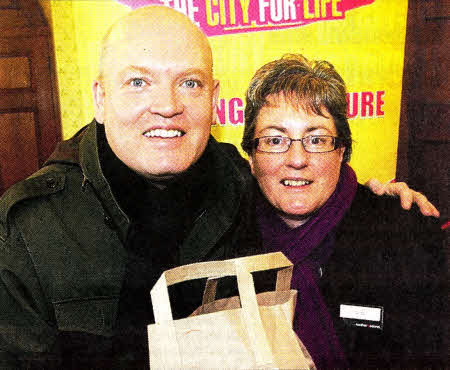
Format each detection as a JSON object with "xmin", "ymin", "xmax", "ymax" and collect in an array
[{"xmin": 0, "ymin": 7, "xmax": 440, "ymax": 369}]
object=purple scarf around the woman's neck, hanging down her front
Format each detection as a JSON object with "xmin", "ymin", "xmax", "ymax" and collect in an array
[{"xmin": 256, "ymin": 164, "xmax": 357, "ymax": 369}]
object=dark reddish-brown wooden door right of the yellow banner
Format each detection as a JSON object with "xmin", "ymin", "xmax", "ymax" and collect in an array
[{"xmin": 397, "ymin": 0, "xmax": 450, "ymax": 223}]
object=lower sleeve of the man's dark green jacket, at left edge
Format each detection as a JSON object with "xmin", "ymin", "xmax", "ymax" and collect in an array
[{"xmin": 0, "ymin": 215, "xmax": 57, "ymax": 369}]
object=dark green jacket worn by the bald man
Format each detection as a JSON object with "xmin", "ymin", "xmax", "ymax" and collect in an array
[{"xmin": 0, "ymin": 121, "xmax": 251, "ymax": 368}]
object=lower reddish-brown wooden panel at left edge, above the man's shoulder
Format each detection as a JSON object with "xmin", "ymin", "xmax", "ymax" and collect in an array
[{"xmin": 0, "ymin": 112, "xmax": 38, "ymax": 189}]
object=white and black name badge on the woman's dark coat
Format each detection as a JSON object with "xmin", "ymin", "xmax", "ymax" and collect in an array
[{"xmin": 339, "ymin": 304, "xmax": 384, "ymax": 330}]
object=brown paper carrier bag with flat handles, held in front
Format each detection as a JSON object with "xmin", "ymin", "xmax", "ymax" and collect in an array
[{"xmin": 148, "ymin": 252, "xmax": 314, "ymax": 369}]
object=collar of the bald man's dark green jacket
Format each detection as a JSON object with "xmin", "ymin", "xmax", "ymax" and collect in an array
[{"xmin": 46, "ymin": 120, "xmax": 249, "ymax": 264}]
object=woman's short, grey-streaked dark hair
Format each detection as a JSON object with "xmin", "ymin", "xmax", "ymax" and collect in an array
[{"xmin": 241, "ymin": 54, "xmax": 352, "ymax": 162}]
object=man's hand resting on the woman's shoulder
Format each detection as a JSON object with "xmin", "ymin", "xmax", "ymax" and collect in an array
[{"xmin": 364, "ymin": 178, "xmax": 439, "ymax": 217}]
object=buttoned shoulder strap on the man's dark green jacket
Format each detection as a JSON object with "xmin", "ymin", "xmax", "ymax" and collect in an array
[{"xmin": 0, "ymin": 165, "xmax": 67, "ymax": 240}]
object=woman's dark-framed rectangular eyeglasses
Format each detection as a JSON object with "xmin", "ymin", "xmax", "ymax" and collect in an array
[{"xmin": 253, "ymin": 135, "xmax": 342, "ymax": 153}]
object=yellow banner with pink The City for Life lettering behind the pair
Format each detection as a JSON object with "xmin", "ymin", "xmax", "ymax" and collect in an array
[{"xmin": 51, "ymin": 0, "xmax": 407, "ymax": 182}]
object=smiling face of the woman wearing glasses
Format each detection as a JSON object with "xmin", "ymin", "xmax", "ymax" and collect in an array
[{"xmin": 249, "ymin": 96, "xmax": 345, "ymax": 227}]
